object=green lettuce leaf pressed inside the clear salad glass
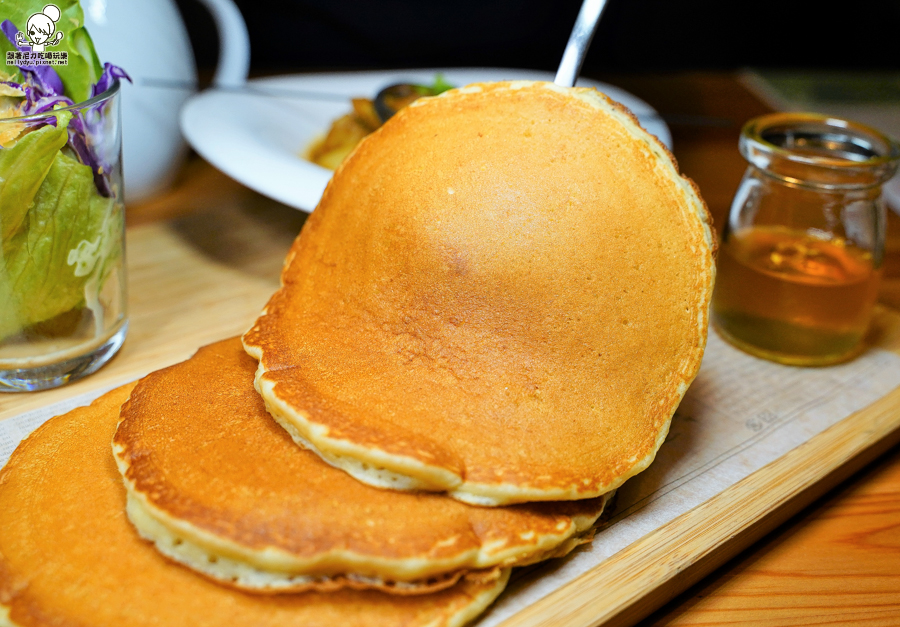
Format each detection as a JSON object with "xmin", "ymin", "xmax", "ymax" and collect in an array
[{"xmin": 0, "ymin": 144, "xmax": 123, "ymax": 340}]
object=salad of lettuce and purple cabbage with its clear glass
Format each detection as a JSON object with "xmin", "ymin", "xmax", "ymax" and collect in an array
[{"xmin": 0, "ymin": 0, "xmax": 127, "ymax": 391}]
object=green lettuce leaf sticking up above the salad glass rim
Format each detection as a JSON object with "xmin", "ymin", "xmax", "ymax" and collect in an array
[{"xmin": 0, "ymin": 0, "xmax": 103, "ymax": 102}]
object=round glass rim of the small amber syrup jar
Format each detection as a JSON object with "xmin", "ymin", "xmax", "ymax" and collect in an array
[{"xmin": 741, "ymin": 112, "xmax": 900, "ymax": 171}]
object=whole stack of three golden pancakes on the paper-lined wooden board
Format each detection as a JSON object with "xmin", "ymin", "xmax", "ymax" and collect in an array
[{"xmin": 0, "ymin": 82, "xmax": 714, "ymax": 627}]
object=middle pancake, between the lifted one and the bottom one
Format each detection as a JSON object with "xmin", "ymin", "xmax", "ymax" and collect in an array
[{"xmin": 113, "ymin": 338, "xmax": 603, "ymax": 594}]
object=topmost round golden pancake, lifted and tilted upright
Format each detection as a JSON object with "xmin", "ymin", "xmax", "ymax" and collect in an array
[{"xmin": 244, "ymin": 82, "xmax": 715, "ymax": 505}]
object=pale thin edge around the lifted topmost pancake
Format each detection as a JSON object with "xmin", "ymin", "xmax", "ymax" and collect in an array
[{"xmin": 241, "ymin": 81, "xmax": 717, "ymax": 507}]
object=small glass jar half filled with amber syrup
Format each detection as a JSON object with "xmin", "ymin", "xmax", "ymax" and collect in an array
[{"xmin": 712, "ymin": 113, "xmax": 900, "ymax": 366}]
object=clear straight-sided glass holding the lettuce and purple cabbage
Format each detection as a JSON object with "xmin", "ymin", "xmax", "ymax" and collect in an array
[{"xmin": 0, "ymin": 82, "xmax": 128, "ymax": 391}]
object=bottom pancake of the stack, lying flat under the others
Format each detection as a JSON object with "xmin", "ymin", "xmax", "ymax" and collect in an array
[{"xmin": 0, "ymin": 386, "xmax": 508, "ymax": 627}]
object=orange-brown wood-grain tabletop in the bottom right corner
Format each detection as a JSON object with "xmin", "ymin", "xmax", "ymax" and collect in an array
[{"xmin": 644, "ymin": 451, "xmax": 900, "ymax": 627}]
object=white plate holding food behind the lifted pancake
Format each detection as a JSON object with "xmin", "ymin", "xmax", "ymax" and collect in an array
[{"xmin": 181, "ymin": 68, "xmax": 672, "ymax": 211}]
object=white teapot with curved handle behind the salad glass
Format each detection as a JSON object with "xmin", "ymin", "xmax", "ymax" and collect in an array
[{"xmin": 81, "ymin": 0, "xmax": 250, "ymax": 202}]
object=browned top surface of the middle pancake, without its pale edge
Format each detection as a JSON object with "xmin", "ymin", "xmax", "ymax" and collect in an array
[{"xmin": 114, "ymin": 338, "xmax": 602, "ymax": 577}]
